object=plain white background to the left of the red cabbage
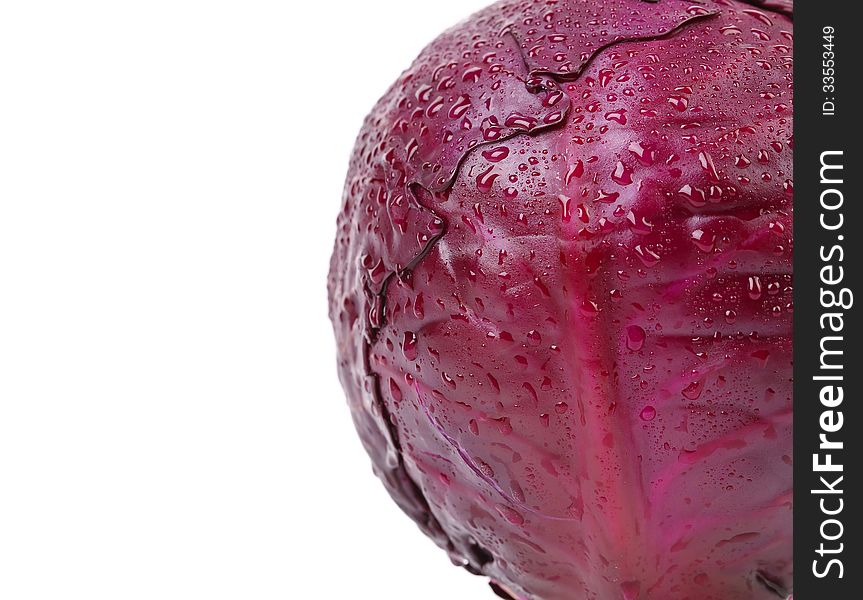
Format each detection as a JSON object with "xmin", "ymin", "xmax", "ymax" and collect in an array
[{"xmin": 0, "ymin": 0, "xmax": 492, "ymax": 600}]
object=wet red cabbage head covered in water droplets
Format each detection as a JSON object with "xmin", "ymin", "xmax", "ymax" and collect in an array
[{"xmin": 329, "ymin": 0, "xmax": 793, "ymax": 600}]
